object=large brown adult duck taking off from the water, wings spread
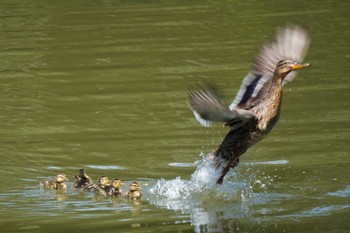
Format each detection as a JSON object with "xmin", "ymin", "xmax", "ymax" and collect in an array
[{"xmin": 188, "ymin": 26, "xmax": 309, "ymax": 184}]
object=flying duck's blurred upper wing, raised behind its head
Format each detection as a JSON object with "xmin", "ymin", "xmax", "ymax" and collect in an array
[{"xmin": 230, "ymin": 25, "xmax": 310, "ymax": 109}]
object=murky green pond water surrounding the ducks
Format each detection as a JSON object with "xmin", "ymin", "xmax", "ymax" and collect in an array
[{"xmin": 0, "ymin": 0, "xmax": 350, "ymax": 233}]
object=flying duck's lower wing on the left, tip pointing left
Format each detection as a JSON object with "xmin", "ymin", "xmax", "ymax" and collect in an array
[{"xmin": 188, "ymin": 87, "xmax": 255, "ymax": 127}]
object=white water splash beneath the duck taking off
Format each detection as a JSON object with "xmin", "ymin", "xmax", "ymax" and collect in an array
[{"xmin": 149, "ymin": 155, "xmax": 252, "ymax": 209}]
